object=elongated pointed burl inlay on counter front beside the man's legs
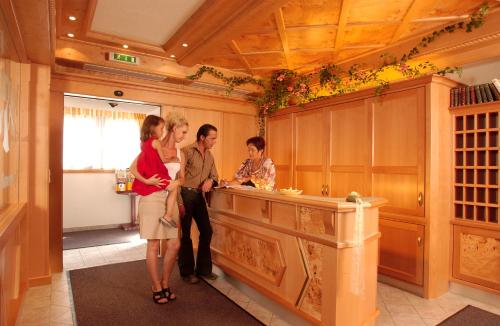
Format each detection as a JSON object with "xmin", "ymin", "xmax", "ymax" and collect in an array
[{"xmin": 211, "ymin": 220, "xmax": 286, "ymax": 285}]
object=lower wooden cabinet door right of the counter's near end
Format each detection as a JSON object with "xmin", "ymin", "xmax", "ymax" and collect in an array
[{"xmin": 378, "ymin": 219, "xmax": 424, "ymax": 285}]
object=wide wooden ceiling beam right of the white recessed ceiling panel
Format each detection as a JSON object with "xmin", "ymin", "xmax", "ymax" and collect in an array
[{"xmin": 163, "ymin": 0, "xmax": 288, "ymax": 66}]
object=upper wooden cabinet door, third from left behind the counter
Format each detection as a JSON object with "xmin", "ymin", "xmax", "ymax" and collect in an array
[{"xmin": 327, "ymin": 100, "xmax": 371, "ymax": 197}]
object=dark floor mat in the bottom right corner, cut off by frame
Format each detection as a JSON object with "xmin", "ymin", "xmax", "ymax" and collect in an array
[{"xmin": 438, "ymin": 305, "xmax": 500, "ymax": 326}]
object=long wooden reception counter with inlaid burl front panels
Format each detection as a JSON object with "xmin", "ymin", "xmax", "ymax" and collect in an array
[{"xmin": 209, "ymin": 189, "xmax": 385, "ymax": 325}]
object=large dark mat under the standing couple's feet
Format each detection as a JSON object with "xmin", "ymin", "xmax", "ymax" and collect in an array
[{"xmin": 69, "ymin": 260, "xmax": 263, "ymax": 326}]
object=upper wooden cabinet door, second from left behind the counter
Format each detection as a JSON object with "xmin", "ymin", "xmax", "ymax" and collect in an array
[{"xmin": 294, "ymin": 110, "xmax": 328, "ymax": 196}]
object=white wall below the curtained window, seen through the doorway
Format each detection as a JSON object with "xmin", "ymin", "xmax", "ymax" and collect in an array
[{"xmin": 63, "ymin": 173, "xmax": 130, "ymax": 229}]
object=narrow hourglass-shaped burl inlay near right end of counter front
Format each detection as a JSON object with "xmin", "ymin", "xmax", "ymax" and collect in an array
[{"xmin": 299, "ymin": 240, "xmax": 323, "ymax": 320}]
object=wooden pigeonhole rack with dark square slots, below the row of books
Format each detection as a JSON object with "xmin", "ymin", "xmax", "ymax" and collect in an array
[{"xmin": 453, "ymin": 111, "xmax": 500, "ymax": 225}]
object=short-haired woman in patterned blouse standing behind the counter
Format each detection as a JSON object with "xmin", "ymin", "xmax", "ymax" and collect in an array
[{"xmin": 226, "ymin": 137, "xmax": 276, "ymax": 190}]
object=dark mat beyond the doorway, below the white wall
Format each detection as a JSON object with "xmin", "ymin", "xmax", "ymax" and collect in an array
[{"xmin": 63, "ymin": 228, "xmax": 140, "ymax": 250}]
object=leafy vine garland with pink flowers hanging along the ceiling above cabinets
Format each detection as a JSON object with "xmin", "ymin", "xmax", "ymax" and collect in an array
[{"xmin": 187, "ymin": 4, "xmax": 488, "ymax": 119}]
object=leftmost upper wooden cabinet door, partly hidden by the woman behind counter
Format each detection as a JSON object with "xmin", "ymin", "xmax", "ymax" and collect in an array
[{"xmin": 266, "ymin": 114, "xmax": 293, "ymax": 189}]
